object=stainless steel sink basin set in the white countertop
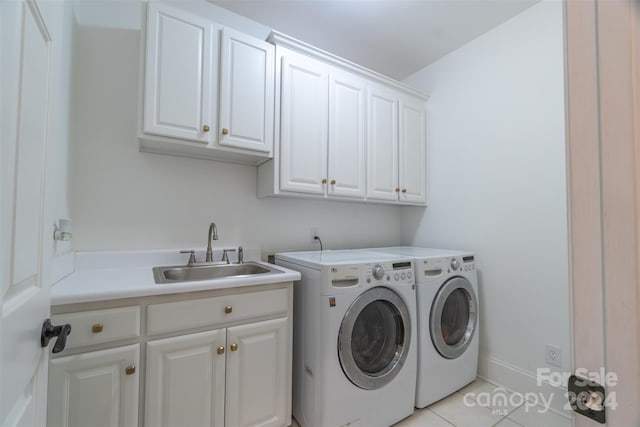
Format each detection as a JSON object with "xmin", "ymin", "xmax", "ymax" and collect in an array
[{"xmin": 153, "ymin": 262, "xmax": 282, "ymax": 284}]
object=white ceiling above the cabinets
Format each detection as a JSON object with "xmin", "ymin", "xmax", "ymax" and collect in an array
[{"xmin": 209, "ymin": 0, "xmax": 539, "ymax": 80}]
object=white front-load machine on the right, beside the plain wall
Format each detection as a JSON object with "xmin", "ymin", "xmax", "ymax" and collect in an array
[{"xmin": 366, "ymin": 246, "xmax": 479, "ymax": 408}]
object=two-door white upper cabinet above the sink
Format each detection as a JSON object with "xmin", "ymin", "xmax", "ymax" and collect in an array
[{"xmin": 139, "ymin": 2, "xmax": 275, "ymax": 164}]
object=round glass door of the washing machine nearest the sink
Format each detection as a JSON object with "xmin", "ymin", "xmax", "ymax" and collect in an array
[{"xmin": 338, "ymin": 287, "xmax": 411, "ymax": 390}]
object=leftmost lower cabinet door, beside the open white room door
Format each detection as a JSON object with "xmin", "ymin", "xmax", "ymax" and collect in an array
[{"xmin": 47, "ymin": 344, "xmax": 140, "ymax": 427}]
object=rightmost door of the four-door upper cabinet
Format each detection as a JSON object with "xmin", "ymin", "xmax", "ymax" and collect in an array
[{"xmin": 399, "ymin": 98, "xmax": 427, "ymax": 204}]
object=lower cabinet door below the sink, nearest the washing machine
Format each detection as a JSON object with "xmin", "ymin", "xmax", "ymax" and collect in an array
[{"xmin": 226, "ymin": 317, "xmax": 291, "ymax": 426}]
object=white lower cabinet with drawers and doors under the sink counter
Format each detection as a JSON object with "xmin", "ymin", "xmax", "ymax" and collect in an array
[{"xmin": 47, "ymin": 282, "xmax": 293, "ymax": 427}]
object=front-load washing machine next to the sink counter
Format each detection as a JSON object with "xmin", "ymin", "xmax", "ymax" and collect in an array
[{"xmin": 275, "ymin": 250, "xmax": 417, "ymax": 427}]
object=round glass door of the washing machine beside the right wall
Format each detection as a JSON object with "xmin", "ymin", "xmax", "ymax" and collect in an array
[{"xmin": 429, "ymin": 277, "xmax": 478, "ymax": 359}]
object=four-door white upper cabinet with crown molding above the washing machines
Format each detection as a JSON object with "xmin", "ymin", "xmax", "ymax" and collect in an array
[{"xmin": 258, "ymin": 32, "xmax": 427, "ymax": 205}]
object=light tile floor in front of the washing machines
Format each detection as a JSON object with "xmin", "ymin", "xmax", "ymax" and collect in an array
[{"xmin": 292, "ymin": 379, "xmax": 571, "ymax": 427}]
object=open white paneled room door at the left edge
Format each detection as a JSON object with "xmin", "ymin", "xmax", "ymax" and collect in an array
[{"xmin": 0, "ymin": 0, "xmax": 53, "ymax": 425}]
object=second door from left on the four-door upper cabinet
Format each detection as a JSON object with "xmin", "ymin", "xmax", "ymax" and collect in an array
[{"xmin": 328, "ymin": 70, "xmax": 366, "ymax": 199}]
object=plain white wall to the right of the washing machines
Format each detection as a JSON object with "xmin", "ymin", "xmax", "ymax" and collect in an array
[{"xmin": 402, "ymin": 1, "xmax": 570, "ymax": 402}]
